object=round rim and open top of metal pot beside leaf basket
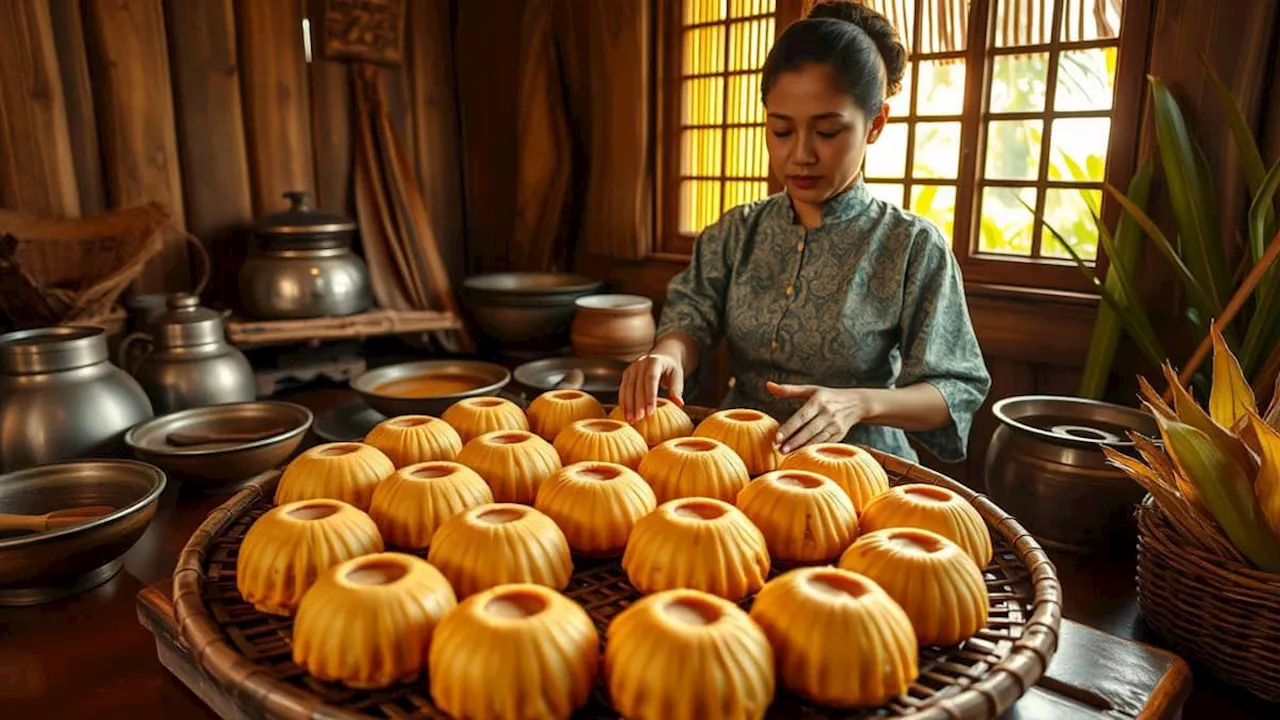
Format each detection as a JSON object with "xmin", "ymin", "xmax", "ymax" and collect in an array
[{"xmin": 991, "ymin": 395, "xmax": 1160, "ymax": 450}]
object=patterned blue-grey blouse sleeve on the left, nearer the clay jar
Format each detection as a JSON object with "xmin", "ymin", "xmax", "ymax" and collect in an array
[{"xmin": 655, "ymin": 209, "xmax": 745, "ymax": 384}]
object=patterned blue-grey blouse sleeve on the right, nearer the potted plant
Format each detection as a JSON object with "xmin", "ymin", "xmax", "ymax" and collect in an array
[{"xmin": 897, "ymin": 227, "xmax": 991, "ymax": 462}]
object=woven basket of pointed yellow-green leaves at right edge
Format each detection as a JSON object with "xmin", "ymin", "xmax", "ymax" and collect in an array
[{"xmin": 1105, "ymin": 327, "xmax": 1280, "ymax": 702}]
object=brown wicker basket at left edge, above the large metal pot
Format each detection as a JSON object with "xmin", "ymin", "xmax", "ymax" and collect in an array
[{"xmin": 0, "ymin": 202, "xmax": 169, "ymax": 327}]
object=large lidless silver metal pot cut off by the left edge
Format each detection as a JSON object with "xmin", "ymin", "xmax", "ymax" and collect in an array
[{"xmin": 0, "ymin": 325, "xmax": 154, "ymax": 473}]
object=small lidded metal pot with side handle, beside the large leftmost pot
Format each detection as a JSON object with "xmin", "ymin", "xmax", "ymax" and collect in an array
[{"xmin": 120, "ymin": 293, "xmax": 257, "ymax": 415}]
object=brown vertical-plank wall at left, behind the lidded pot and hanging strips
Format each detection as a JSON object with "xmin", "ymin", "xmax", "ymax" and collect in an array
[{"xmin": 0, "ymin": 0, "xmax": 465, "ymax": 302}]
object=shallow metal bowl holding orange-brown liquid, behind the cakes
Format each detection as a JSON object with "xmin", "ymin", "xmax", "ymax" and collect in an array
[{"xmin": 351, "ymin": 360, "xmax": 511, "ymax": 418}]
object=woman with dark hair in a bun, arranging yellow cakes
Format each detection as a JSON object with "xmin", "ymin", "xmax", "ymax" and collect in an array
[{"xmin": 620, "ymin": 1, "xmax": 991, "ymax": 461}]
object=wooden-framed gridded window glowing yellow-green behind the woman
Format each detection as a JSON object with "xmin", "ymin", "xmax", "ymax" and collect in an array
[{"xmin": 663, "ymin": 0, "xmax": 1149, "ymax": 291}]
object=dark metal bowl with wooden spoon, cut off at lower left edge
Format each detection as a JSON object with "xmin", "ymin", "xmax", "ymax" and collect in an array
[{"xmin": 0, "ymin": 460, "xmax": 165, "ymax": 606}]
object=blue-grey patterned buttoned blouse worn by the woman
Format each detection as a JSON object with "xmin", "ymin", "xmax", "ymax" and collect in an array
[{"xmin": 658, "ymin": 181, "xmax": 991, "ymax": 461}]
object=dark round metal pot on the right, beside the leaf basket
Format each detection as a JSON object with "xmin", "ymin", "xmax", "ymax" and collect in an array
[{"xmin": 986, "ymin": 396, "xmax": 1160, "ymax": 553}]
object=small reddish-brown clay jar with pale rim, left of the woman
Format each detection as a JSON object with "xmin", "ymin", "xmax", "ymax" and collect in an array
[{"xmin": 570, "ymin": 295, "xmax": 657, "ymax": 363}]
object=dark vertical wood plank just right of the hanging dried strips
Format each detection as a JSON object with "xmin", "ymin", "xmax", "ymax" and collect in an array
[{"xmin": 453, "ymin": 0, "xmax": 525, "ymax": 273}]
